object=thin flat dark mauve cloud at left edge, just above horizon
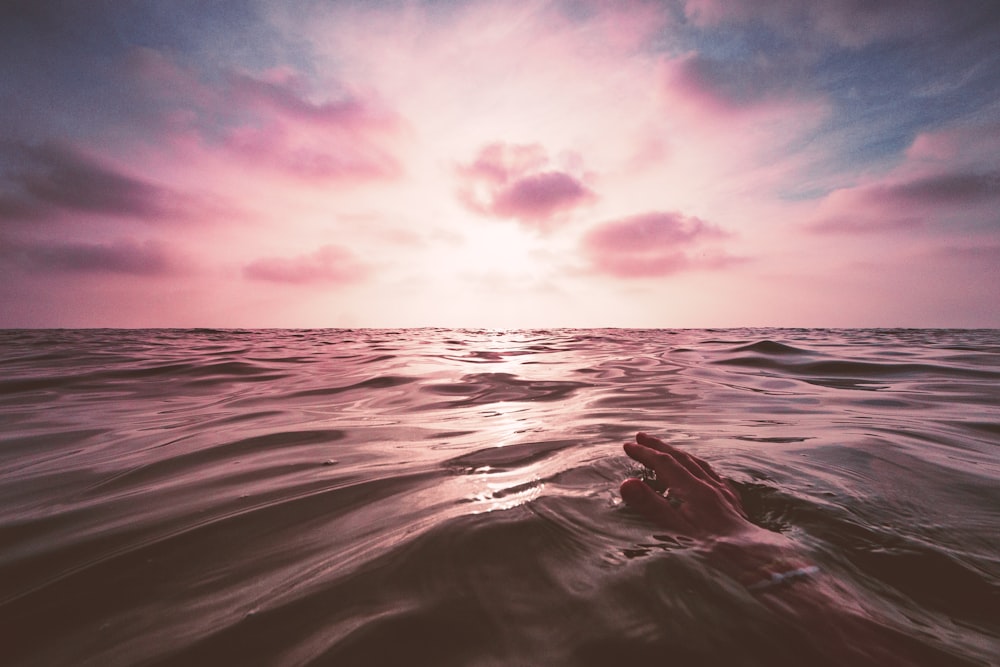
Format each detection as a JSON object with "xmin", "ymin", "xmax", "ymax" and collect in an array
[{"xmin": 0, "ymin": 240, "xmax": 178, "ymax": 276}]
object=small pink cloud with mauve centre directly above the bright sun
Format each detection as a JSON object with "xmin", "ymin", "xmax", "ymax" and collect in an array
[{"xmin": 459, "ymin": 143, "xmax": 596, "ymax": 229}]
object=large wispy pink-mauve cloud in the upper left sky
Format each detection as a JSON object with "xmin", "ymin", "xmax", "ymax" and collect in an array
[{"xmin": 128, "ymin": 48, "xmax": 401, "ymax": 184}]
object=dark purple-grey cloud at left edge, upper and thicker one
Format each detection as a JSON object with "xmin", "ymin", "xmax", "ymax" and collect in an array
[{"xmin": 0, "ymin": 143, "xmax": 188, "ymax": 220}]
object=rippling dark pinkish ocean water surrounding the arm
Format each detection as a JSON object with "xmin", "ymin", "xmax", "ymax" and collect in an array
[{"xmin": 0, "ymin": 329, "xmax": 1000, "ymax": 666}]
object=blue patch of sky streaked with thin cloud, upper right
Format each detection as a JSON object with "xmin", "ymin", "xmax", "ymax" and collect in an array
[{"xmin": 655, "ymin": 8, "xmax": 1000, "ymax": 199}]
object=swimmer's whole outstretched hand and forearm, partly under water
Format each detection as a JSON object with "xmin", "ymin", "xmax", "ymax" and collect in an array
[{"xmin": 621, "ymin": 433, "xmax": 966, "ymax": 667}]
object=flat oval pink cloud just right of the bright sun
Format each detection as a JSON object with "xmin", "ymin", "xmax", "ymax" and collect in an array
[{"xmin": 583, "ymin": 212, "xmax": 742, "ymax": 278}]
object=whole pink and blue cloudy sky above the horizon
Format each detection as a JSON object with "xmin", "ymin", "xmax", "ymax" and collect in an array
[{"xmin": 0, "ymin": 0, "xmax": 1000, "ymax": 328}]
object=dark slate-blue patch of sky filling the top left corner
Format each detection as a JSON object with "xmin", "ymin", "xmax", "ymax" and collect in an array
[{"xmin": 0, "ymin": 0, "xmax": 313, "ymax": 143}]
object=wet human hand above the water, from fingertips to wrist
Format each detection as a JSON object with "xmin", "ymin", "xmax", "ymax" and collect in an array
[{"xmin": 621, "ymin": 433, "xmax": 757, "ymax": 538}]
